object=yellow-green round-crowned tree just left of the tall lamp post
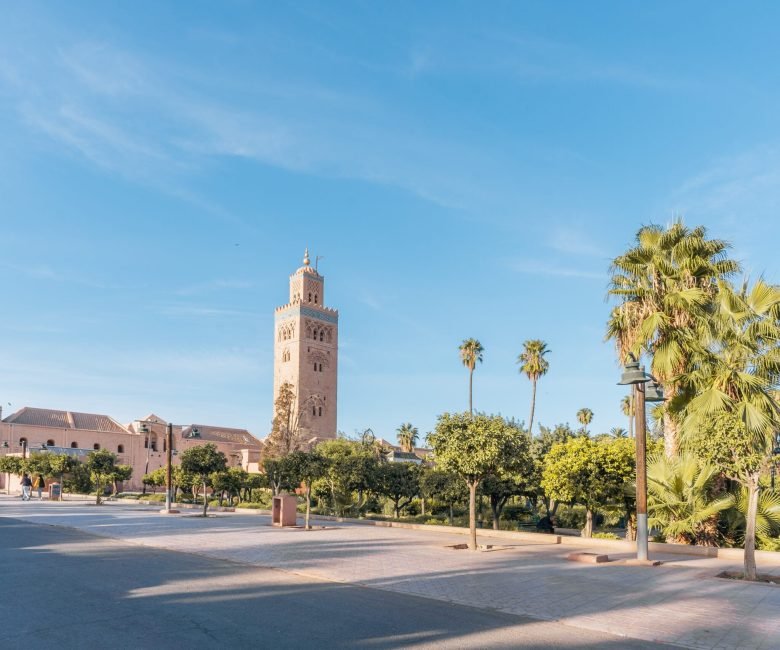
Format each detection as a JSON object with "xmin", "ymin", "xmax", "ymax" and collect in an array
[{"xmin": 542, "ymin": 436, "xmax": 634, "ymax": 537}]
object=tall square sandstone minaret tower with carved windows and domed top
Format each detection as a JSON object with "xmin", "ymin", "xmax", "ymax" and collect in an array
[{"xmin": 274, "ymin": 248, "xmax": 339, "ymax": 439}]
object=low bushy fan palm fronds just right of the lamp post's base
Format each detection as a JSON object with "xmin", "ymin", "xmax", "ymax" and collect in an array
[{"xmin": 647, "ymin": 453, "xmax": 734, "ymax": 546}]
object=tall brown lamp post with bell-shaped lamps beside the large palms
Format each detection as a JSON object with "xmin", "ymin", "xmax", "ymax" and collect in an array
[{"xmin": 618, "ymin": 361, "xmax": 664, "ymax": 562}]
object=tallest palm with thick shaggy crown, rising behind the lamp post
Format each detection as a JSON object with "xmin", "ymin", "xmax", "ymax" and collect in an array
[{"xmin": 607, "ymin": 220, "xmax": 740, "ymax": 457}]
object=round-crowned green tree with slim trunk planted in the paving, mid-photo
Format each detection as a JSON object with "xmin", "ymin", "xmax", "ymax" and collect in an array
[{"xmin": 428, "ymin": 413, "xmax": 527, "ymax": 551}]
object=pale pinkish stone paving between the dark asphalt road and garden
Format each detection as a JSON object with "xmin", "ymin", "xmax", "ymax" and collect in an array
[{"xmin": 0, "ymin": 499, "xmax": 780, "ymax": 649}]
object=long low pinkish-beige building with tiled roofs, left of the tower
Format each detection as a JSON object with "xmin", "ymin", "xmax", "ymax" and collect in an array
[{"xmin": 0, "ymin": 407, "xmax": 262, "ymax": 490}]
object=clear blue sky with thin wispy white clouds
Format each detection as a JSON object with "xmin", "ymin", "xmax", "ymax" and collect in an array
[{"xmin": 0, "ymin": 1, "xmax": 780, "ymax": 438}]
